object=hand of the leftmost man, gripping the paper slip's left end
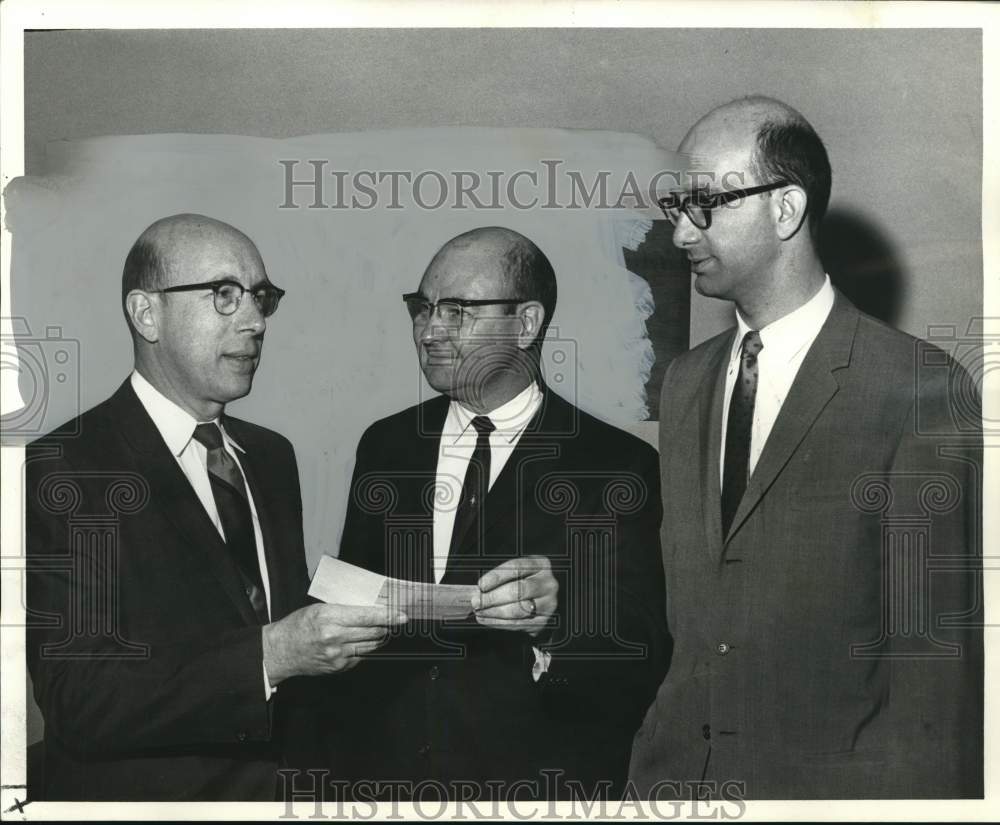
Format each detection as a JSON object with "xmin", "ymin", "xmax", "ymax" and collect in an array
[{"xmin": 263, "ymin": 604, "xmax": 407, "ymax": 687}]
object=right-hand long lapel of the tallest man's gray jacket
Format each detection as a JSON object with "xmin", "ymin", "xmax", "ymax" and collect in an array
[{"xmin": 726, "ymin": 292, "xmax": 859, "ymax": 541}]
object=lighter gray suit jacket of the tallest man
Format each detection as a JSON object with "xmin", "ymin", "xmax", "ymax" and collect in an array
[{"xmin": 631, "ymin": 294, "xmax": 983, "ymax": 799}]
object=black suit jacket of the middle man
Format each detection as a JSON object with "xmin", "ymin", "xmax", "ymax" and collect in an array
[{"xmin": 329, "ymin": 391, "xmax": 669, "ymax": 798}]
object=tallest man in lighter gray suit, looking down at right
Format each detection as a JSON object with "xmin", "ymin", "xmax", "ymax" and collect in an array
[{"xmin": 630, "ymin": 98, "xmax": 983, "ymax": 799}]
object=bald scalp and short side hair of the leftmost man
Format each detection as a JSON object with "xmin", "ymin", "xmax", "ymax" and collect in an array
[{"xmin": 122, "ymin": 214, "xmax": 260, "ymax": 322}]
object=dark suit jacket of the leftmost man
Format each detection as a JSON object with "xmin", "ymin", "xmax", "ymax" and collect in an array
[{"xmin": 26, "ymin": 381, "xmax": 308, "ymax": 800}]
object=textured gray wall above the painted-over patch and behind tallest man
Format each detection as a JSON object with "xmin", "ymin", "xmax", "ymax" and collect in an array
[{"xmin": 25, "ymin": 29, "xmax": 982, "ymax": 343}]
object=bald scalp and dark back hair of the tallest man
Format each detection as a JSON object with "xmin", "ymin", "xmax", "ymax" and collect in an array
[{"xmin": 680, "ymin": 95, "xmax": 831, "ymax": 237}]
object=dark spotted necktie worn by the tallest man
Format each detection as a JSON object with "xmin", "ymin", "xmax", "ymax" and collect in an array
[{"xmin": 722, "ymin": 330, "xmax": 764, "ymax": 536}]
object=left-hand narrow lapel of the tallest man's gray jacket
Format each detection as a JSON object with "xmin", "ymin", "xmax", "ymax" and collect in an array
[{"xmin": 698, "ymin": 331, "xmax": 736, "ymax": 552}]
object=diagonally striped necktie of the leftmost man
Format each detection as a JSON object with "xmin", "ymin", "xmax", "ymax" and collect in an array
[{"xmin": 194, "ymin": 423, "xmax": 268, "ymax": 624}]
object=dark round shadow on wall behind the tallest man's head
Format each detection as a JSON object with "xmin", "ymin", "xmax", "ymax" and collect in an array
[{"xmin": 819, "ymin": 209, "xmax": 906, "ymax": 326}]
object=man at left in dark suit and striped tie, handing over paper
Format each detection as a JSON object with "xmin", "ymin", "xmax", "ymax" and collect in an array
[{"xmin": 26, "ymin": 215, "xmax": 402, "ymax": 800}]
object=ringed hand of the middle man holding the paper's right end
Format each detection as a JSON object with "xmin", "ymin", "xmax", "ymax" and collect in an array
[{"xmin": 472, "ymin": 556, "xmax": 559, "ymax": 636}]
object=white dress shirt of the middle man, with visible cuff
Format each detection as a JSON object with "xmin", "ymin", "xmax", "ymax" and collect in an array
[{"xmin": 434, "ymin": 382, "xmax": 552, "ymax": 682}]
